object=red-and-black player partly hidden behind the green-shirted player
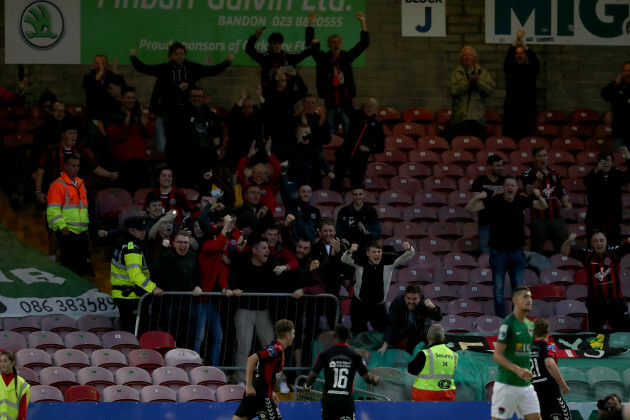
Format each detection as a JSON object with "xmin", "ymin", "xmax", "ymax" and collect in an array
[{"xmin": 530, "ymin": 318, "xmax": 571, "ymax": 420}]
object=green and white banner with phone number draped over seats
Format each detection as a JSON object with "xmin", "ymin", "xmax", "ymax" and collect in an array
[{"xmin": 0, "ymin": 225, "xmax": 118, "ymax": 318}]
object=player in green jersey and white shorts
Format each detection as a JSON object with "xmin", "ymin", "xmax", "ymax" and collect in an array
[{"xmin": 491, "ymin": 286, "xmax": 541, "ymax": 420}]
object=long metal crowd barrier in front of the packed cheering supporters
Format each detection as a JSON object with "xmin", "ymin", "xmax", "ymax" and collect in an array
[{"xmin": 135, "ymin": 292, "xmax": 340, "ymax": 374}]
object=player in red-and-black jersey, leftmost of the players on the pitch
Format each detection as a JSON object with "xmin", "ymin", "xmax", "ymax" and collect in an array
[{"xmin": 232, "ymin": 319, "xmax": 295, "ymax": 420}]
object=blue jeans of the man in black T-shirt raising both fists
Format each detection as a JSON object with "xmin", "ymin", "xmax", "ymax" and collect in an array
[{"xmin": 490, "ymin": 249, "xmax": 526, "ymax": 318}]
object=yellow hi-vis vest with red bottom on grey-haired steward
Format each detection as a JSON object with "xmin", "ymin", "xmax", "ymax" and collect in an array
[{"xmin": 412, "ymin": 344, "xmax": 457, "ymax": 401}]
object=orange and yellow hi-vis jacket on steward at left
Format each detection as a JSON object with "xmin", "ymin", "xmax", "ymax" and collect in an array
[{"xmin": 46, "ymin": 172, "xmax": 90, "ymax": 234}]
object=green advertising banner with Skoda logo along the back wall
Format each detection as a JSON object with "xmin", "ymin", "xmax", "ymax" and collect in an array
[{"xmin": 5, "ymin": 0, "xmax": 370, "ymax": 67}]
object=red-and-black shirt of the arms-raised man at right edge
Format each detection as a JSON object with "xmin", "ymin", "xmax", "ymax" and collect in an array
[{"xmin": 569, "ymin": 243, "xmax": 630, "ymax": 299}]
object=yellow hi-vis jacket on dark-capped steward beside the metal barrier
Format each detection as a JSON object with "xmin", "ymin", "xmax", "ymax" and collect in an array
[{"xmin": 110, "ymin": 241, "xmax": 155, "ymax": 299}]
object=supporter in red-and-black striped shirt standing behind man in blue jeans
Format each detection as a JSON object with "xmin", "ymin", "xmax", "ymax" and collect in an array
[{"xmin": 523, "ymin": 146, "xmax": 571, "ymax": 253}]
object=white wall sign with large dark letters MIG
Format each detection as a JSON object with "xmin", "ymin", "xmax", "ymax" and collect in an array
[{"xmin": 486, "ymin": 0, "xmax": 630, "ymax": 46}]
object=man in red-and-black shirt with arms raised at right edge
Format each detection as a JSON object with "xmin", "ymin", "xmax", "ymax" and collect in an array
[{"xmin": 562, "ymin": 229, "xmax": 630, "ymax": 332}]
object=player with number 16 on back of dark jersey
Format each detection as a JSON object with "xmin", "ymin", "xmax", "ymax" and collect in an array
[{"xmin": 304, "ymin": 324, "xmax": 379, "ymax": 420}]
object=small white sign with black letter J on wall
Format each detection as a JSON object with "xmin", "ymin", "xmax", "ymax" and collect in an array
[{"xmin": 400, "ymin": 0, "xmax": 446, "ymax": 37}]
